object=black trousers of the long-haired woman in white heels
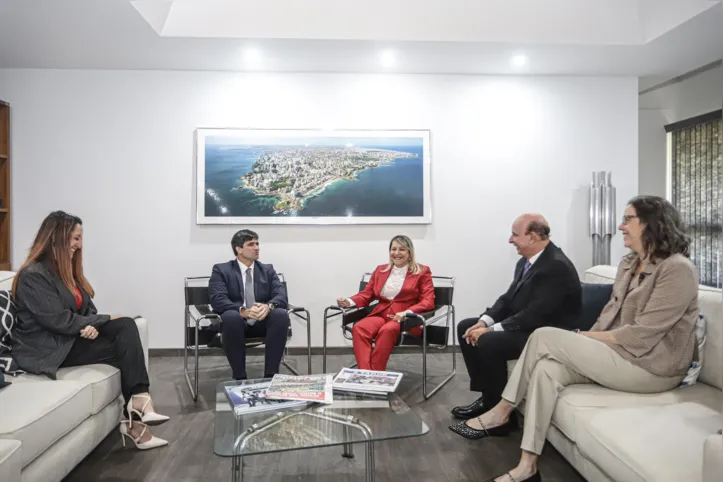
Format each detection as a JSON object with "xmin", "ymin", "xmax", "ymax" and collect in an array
[{"xmin": 60, "ymin": 318, "xmax": 150, "ymax": 410}]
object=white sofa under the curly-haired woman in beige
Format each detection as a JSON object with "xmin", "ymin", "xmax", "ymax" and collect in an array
[{"xmin": 528, "ymin": 266, "xmax": 723, "ymax": 482}]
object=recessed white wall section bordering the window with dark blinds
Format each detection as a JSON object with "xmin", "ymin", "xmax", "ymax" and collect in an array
[{"xmin": 638, "ymin": 67, "xmax": 723, "ymax": 196}]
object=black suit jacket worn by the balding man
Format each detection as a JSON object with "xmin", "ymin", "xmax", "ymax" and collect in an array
[{"xmin": 484, "ymin": 242, "xmax": 582, "ymax": 333}]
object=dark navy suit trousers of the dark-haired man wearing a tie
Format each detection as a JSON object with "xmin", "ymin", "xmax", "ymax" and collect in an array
[{"xmin": 221, "ymin": 308, "xmax": 291, "ymax": 380}]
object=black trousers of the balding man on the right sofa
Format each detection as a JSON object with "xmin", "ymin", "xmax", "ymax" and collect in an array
[{"xmin": 457, "ymin": 318, "xmax": 530, "ymax": 408}]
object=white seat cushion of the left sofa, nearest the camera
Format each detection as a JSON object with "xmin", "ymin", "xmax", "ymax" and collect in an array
[{"xmin": 0, "ymin": 379, "xmax": 93, "ymax": 467}]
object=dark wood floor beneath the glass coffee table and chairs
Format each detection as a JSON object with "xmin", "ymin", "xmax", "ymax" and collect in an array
[{"xmin": 60, "ymin": 354, "xmax": 584, "ymax": 482}]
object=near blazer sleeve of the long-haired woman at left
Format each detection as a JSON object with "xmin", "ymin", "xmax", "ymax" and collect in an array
[{"xmin": 15, "ymin": 269, "xmax": 110, "ymax": 336}]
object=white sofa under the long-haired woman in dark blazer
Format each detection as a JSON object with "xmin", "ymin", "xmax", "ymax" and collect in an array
[{"xmin": 0, "ymin": 272, "xmax": 148, "ymax": 482}]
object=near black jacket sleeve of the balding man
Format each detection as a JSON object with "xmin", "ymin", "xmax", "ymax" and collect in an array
[{"xmin": 495, "ymin": 259, "xmax": 580, "ymax": 333}]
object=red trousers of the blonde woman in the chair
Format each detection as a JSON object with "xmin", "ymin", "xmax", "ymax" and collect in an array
[{"xmin": 351, "ymin": 312, "xmax": 402, "ymax": 371}]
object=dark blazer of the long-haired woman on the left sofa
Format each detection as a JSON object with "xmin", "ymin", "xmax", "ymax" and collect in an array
[{"xmin": 12, "ymin": 262, "xmax": 110, "ymax": 379}]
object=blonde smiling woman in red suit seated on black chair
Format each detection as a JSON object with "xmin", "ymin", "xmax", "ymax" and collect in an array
[{"xmin": 336, "ymin": 235, "xmax": 434, "ymax": 371}]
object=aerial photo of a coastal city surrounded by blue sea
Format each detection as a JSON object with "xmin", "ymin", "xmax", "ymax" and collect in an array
[{"xmin": 203, "ymin": 136, "xmax": 425, "ymax": 217}]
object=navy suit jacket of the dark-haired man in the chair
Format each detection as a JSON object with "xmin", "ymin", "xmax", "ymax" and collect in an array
[{"xmin": 208, "ymin": 259, "xmax": 289, "ymax": 314}]
